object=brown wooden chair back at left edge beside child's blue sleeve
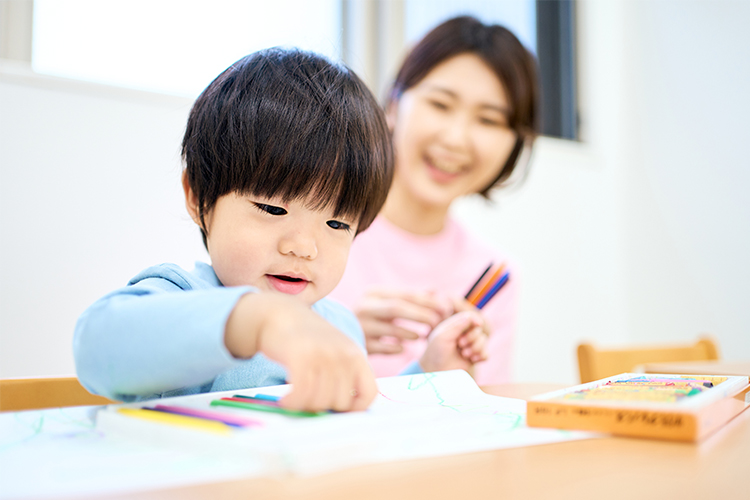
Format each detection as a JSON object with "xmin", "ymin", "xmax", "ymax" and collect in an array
[{"xmin": 0, "ymin": 377, "xmax": 116, "ymax": 411}]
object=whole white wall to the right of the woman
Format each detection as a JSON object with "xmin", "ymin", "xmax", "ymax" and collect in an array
[{"xmin": 458, "ymin": 0, "xmax": 750, "ymax": 382}]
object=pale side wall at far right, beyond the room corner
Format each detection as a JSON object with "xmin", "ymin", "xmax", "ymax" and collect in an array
[{"xmin": 625, "ymin": 1, "xmax": 750, "ymax": 359}]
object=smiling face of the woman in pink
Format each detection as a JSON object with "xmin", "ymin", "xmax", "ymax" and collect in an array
[{"xmin": 388, "ymin": 53, "xmax": 516, "ymax": 208}]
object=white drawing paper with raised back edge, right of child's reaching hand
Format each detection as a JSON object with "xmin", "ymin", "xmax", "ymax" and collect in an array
[{"xmin": 250, "ymin": 370, "xmax": 600, "ymax": 475}]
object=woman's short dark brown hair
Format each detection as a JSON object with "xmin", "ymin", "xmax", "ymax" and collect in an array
[{"xmin": 387, "ymin": 16, "xmax": 539, "ymax": 198}]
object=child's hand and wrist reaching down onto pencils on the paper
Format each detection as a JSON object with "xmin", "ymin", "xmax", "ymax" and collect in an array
[{"xmin": 224, "ymin": 293, "xmax": 377, "ymax": 411}]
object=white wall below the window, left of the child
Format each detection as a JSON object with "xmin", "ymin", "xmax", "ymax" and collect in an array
[{"xmin": 0, "ymin": 66, "xmax": 205, "ymax": 377}]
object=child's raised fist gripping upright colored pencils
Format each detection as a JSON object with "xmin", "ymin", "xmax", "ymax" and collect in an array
[{"xmin": 419, "ymin": 309, "xmax": 487, "ymax": 372}]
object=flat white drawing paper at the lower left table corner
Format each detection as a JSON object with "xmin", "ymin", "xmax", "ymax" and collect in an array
[{"xmin": 0, "ymin": 407, "xmax": 266, "ymax": 499}]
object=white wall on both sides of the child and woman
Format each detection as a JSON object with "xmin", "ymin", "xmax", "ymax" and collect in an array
[{"xmin": 0, "ymin": 0, "xmax": 750, "ymax": 383}]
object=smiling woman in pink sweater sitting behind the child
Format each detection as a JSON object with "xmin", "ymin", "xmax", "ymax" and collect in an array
[{"xmin": 332, "ymin": 17, "xmax": 537, "ymax": 384}]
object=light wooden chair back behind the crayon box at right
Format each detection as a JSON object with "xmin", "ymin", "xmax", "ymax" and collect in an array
[{"xmin": 578, "ymin": 336, "xmax": 719, "ymax": 384}]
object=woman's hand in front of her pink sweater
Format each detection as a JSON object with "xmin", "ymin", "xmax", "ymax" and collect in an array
[{"xmin": 354, "ymin": 288, "xmax": 454, "ymax": 354}]
